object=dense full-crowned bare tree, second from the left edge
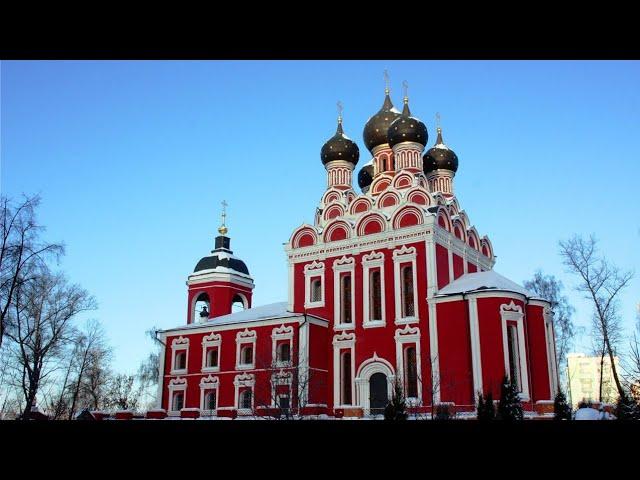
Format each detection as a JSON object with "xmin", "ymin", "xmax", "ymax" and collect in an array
[{"xmin": 5, "ymin": 267, "xmax": 95, "ymax": 419}]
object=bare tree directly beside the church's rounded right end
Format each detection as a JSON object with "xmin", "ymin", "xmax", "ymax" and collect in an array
[{"xmin": 524, "ymin": 270, "xmax": 577, "ymax": 378}]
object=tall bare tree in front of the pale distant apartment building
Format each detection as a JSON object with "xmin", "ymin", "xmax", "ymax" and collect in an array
[{"xmin": 560, "ymin": 235, "xmax": 633, "ymax": 397}]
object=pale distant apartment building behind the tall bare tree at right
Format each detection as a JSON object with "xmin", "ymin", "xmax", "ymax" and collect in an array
[{"xmin": 567, "ymin": 353, "xmax": 620, "ymax": 408}]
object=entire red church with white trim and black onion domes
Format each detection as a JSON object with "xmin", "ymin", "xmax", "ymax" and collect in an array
[{"xmin": 158, "ymin": 89, "xmax": 558, "ymax": 418}]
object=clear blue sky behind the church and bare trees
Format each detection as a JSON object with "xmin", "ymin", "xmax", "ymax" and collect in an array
[{"xmin": 0, "ymin": 61, "xmax": 640, "ymax": 371}]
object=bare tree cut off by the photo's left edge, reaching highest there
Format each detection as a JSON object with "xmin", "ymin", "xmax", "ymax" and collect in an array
[{"xmin": 0, "ymin": 195, "xmax": 64, "ymax": 346}]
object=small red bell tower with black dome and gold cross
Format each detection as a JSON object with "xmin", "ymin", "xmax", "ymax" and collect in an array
[{"xmin": 187, "ymin": 202, "xmax": 254, "ymax": 323}]
